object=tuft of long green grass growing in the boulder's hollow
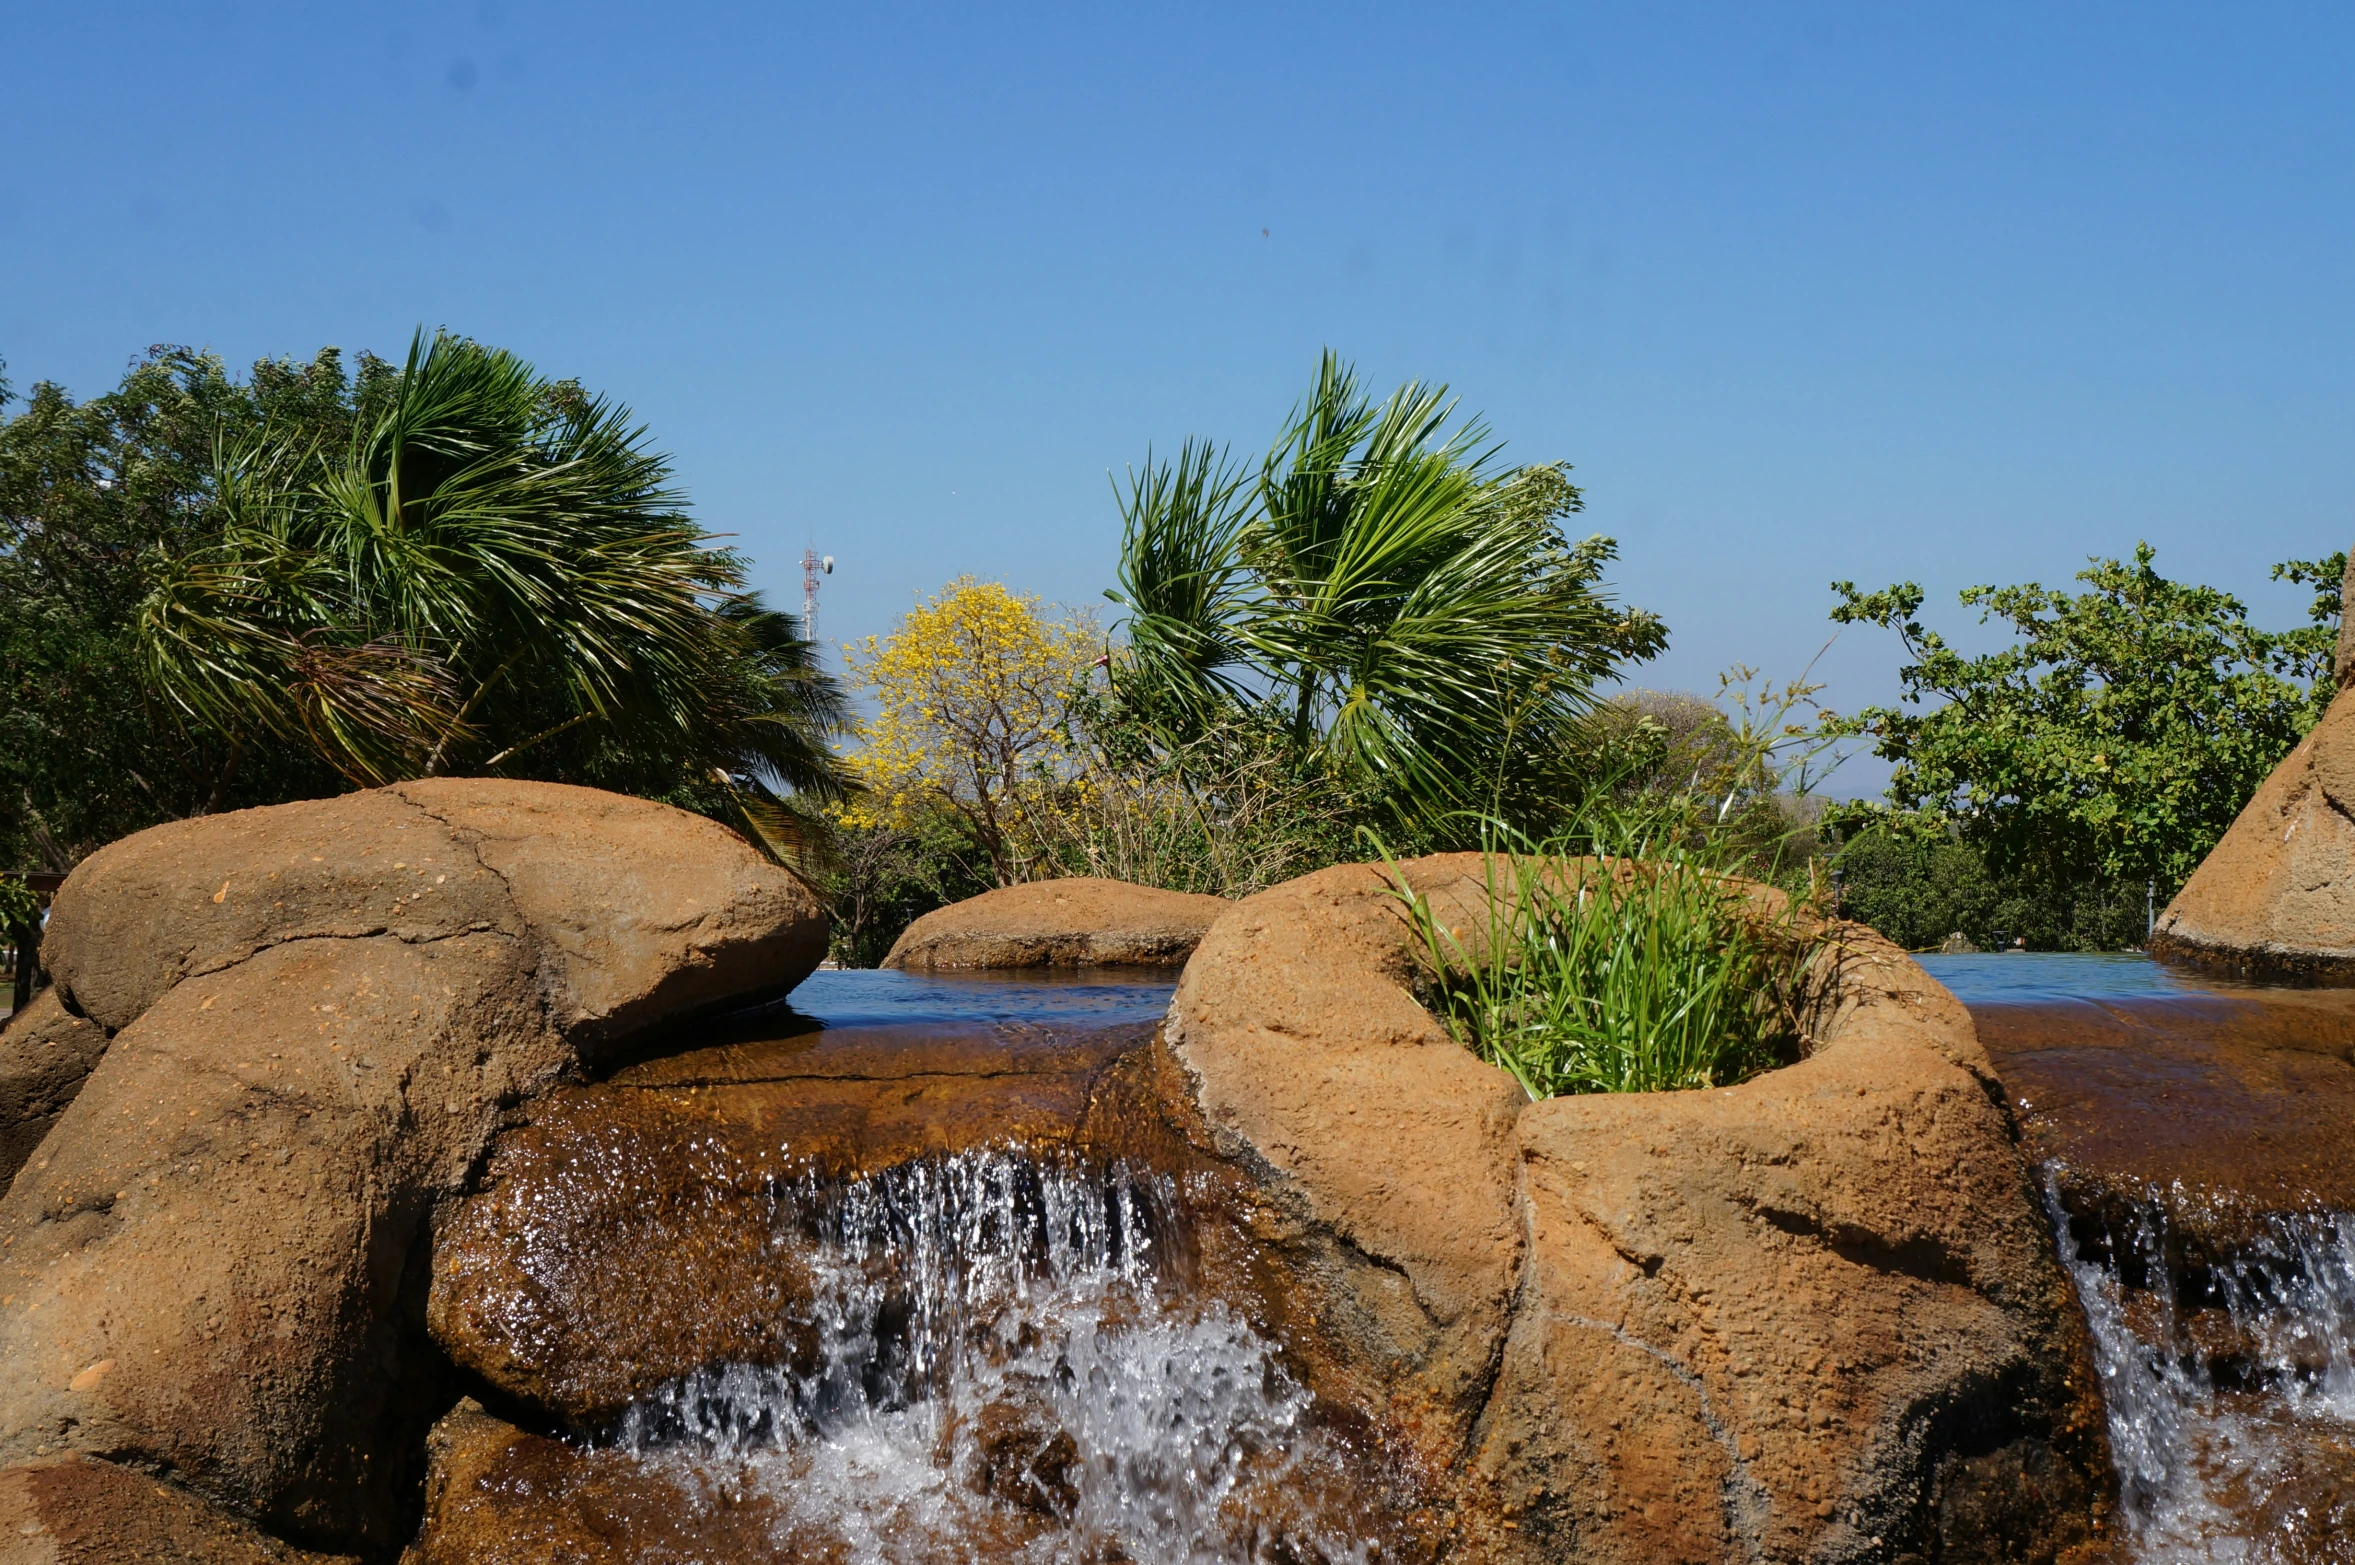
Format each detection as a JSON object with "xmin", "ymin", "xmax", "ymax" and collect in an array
[{"xmin": 1385, "ymin": 831, "xmax": 1818, "ymax": 1099}]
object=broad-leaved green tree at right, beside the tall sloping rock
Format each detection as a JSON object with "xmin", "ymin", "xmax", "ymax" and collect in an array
[{"xmin": 1825, "ymin": 544, "xmax": 2346, "ymax": 932}]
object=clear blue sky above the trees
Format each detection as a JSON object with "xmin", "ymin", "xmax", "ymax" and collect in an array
[{"xmin": 0, "ymin": 0, "xmax": 2355, "ymax": 795}]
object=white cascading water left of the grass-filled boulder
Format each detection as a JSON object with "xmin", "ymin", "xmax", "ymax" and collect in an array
[{"xmin": 610, "ymin": 1151, "xmax": 1380, "ymax": 1565}]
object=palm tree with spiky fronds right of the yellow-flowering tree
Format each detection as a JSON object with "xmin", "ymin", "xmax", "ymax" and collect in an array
[{"xmin": 1109, "ymin": 353, "xmax": 1667, "ymax": 824}]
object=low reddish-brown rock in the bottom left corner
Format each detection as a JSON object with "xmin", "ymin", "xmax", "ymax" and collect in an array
[{"xmin": 0, "ymin": 1457, "xmax": 351, "ymax": 1565}]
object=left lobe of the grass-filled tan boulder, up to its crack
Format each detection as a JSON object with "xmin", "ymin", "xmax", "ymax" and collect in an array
[{"xmin": 1168, "ymin": 866, "xmax": 1526, "ymax": 1466}]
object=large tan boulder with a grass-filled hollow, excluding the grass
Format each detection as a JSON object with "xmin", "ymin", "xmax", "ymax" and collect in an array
[{"xmin": 1168, "ymin": 854, "xmax": 2108, "ymax": 1563}]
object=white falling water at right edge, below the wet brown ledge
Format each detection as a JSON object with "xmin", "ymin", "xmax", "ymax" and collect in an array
[{"xmin": 2044, "ymin": 1167, "xmax": 2355, "ymax": 1565}]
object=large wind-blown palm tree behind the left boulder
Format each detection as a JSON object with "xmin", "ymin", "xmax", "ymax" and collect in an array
[{"xmin": 137, "ymin": 332, "xmax": 845, "ymax": 842}]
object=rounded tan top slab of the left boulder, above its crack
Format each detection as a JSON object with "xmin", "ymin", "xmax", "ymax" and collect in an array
[{"xmin": 42, "ymin": 779, "xmax": 827, "ymax": 1047}]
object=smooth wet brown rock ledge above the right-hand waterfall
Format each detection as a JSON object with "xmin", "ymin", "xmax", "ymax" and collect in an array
[{"xmin": 1976, "ymin": 988, "xmax": 2355, "ymax": 1271}]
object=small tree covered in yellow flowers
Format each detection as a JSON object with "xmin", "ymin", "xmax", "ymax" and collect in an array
[{"xmin": 841, "ymin": 577, "xmax": 1104, "ymax": 885}]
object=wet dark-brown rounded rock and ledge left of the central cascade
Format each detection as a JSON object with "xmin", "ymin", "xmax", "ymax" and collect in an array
[{"xmin": 429, "ymin": 1011, "xmax": 1149, "ymax": 1424}]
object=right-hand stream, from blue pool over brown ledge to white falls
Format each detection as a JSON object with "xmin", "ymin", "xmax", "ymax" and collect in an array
[{"xmin": 1926, "ymin": 955, "xmax": 2355, "ymax": 1565}]
